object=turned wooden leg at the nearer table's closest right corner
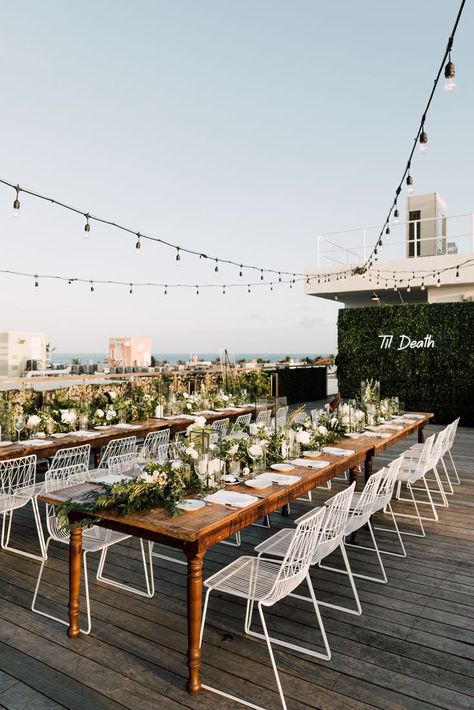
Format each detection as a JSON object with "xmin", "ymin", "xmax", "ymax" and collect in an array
[{"xmin": 187, "ymin": 553, "xmax": 202, "ymax": 695}]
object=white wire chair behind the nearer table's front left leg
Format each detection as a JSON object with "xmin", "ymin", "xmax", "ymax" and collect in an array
[{"xmin": 31, "ymin": 464, "xmax": 155, "ymax": 634}]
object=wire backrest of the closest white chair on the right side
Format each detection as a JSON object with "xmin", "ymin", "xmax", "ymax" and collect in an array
[{"xmin": 261, "ymin": 508, "xmax": 324, "ymax": 606}]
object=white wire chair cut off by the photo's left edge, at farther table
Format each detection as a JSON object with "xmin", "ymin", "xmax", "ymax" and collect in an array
[{"xmin": 0, "ymin": 454, "xmax": 46, "ymax": 560}]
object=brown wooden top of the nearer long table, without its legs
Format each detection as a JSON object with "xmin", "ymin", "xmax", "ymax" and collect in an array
[{"xmin": 39, "ymin": 413, "xmax": 433, "ymax": 550}]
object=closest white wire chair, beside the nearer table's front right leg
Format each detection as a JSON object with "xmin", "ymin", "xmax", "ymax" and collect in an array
[{"xmin": 201, "ymin": 508, "xmax": 329, "ymax": 710}]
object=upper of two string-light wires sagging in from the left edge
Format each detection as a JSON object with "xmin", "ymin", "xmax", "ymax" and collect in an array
[{"xmin": 0, "ymin": 178, "xmax": 302, "ymax": 276}]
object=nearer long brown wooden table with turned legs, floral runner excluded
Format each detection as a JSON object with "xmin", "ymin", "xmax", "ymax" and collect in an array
[{"xmin": 38, "ymin": 413, "xmax": 433, "ymax": 694}]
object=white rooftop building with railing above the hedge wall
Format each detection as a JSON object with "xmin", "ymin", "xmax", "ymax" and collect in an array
[{"xmin": 305, "ymin": 193, "xmax": 474, "ymax": 308}]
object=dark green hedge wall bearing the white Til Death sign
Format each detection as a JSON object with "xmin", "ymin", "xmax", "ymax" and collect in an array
[{"xmin": 338, "ymin": 302, "xmax": 474, "ymax": 426}]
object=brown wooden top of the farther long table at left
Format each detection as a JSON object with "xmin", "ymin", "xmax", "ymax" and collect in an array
[{"xmin": 0, "ymin": 405, "xmax": 255, "ymax": 464}]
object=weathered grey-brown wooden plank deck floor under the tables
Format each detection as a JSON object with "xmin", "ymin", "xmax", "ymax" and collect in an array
[{"xmin": 0, "ymin": 426, "xmax": 474, "ymax": 710}]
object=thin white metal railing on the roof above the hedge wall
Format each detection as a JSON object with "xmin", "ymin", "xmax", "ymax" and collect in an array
[{"xmin": 316, "ymin": 213, "xmax": 474, "ymax": 269}]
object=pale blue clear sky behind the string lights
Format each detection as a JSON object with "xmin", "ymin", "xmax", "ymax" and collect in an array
[{"xmin": 0, "ymin": 0, "xmax": 474, "ymax": 353}]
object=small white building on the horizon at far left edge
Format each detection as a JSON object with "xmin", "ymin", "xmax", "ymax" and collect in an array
[{"xmin": 0, "ymin": 331, "xmax": 47, "ymax": 377}]
